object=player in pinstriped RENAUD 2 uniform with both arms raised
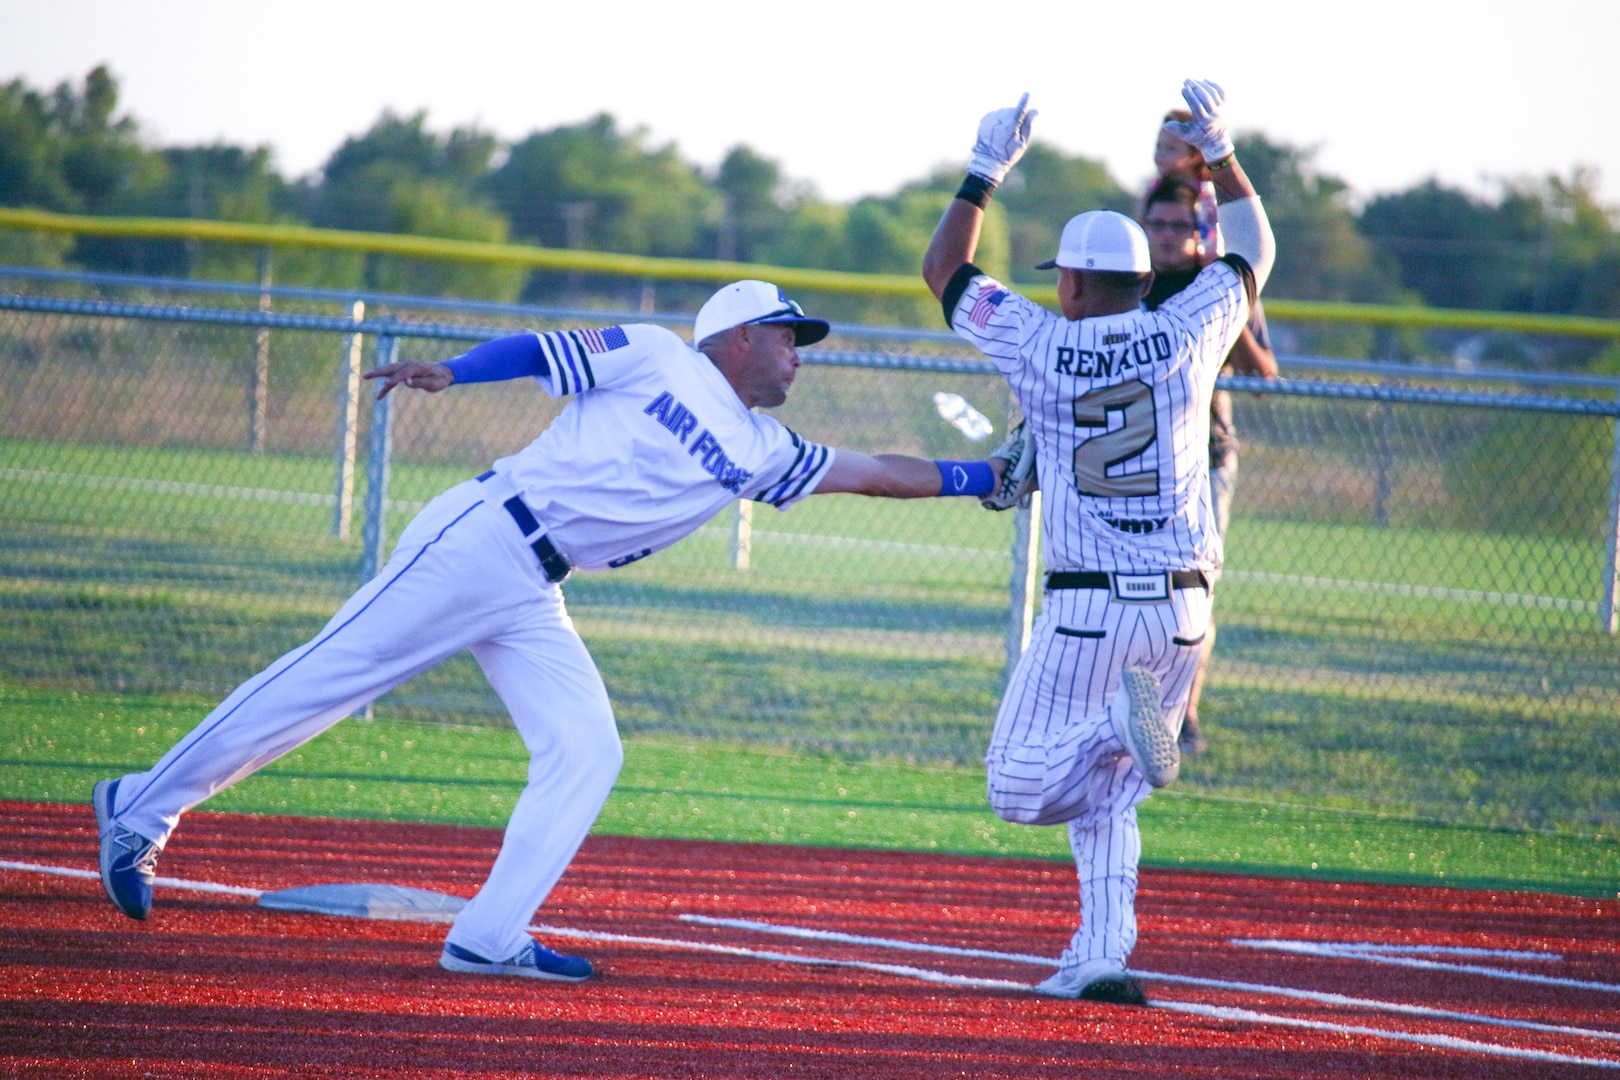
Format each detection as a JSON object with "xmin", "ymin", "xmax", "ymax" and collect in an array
[{"xmin": 923, "ymin": 81, "xmax": 1273, "ymax": 1004}]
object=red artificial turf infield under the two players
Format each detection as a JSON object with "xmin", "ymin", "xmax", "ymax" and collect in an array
[{"xmin": 0, "ymin": 803, "xmax": 1620, "ymax": 1080}]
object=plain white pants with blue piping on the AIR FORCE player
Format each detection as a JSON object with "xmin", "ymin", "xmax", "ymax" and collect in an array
[{"xmin": 102, "ymin": 478, "xmax": 624, "ymax": 959}]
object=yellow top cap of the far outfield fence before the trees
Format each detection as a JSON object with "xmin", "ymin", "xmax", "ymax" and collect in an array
[{"xmin": 9, "ymin": 207, "xmax": 1620, "ymax": 338}]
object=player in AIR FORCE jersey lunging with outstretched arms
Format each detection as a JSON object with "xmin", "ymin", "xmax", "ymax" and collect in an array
[{"xmin": 94, "ymin": 282, "xmax": 1001, "ymax": 981}]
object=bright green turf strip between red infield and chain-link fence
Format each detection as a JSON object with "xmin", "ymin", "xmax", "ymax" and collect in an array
[{"xmin": 0, "ymin": 683, "xmax": 1620, "ymax": 897}]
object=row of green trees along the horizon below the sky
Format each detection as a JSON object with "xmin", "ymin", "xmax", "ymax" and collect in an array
[{"xmin": 0, "ymin": 66, "xmax": 1620, "ymax": 367}]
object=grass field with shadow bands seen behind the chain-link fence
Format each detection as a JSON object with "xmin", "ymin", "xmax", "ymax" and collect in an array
[{"xmin": 9, "ymin": 439, "xmax": 1620, "ymax": 836}]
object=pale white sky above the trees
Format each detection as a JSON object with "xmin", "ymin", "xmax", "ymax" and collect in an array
[{"xmin": 0, "ymin": 0, "xmax": 1620, "ymax": 202}]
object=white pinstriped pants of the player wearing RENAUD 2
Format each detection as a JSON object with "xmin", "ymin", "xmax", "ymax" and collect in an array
[{"xmin": 985, "ymin": 589, "xmax": 1210, "ymax": 967}]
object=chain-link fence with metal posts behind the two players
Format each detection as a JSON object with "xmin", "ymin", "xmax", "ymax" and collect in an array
[{"xmin": 0, "ymin": 268, "xmax": 1620, "ymax": 823}]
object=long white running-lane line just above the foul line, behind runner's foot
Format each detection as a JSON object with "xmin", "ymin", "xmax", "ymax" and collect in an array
[{"xmin": 677, "ymin": 915, "xmax": 1620, "ymax": 1043}]
